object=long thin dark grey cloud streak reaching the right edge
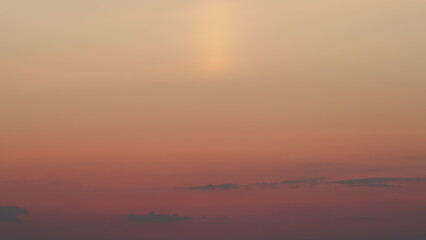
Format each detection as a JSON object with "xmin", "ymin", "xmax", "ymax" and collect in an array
[{"xmin": 331, "ymin": 178, "xmax": 426, "ymax": 187}]
